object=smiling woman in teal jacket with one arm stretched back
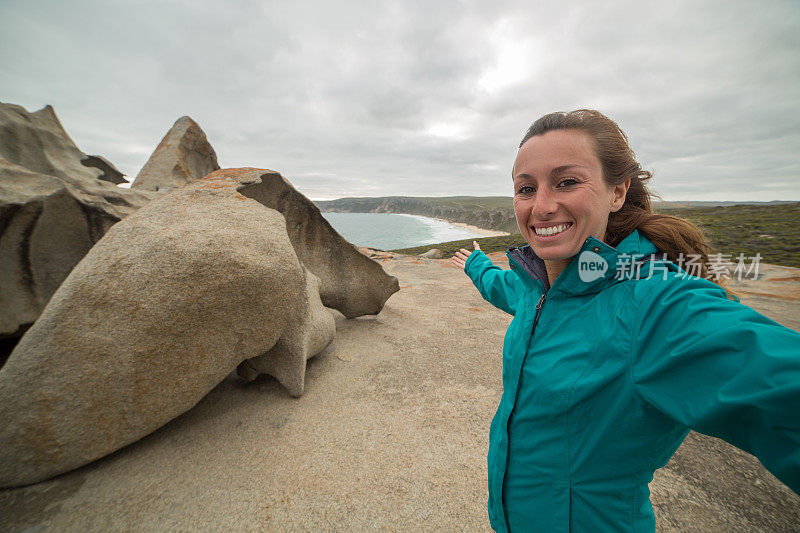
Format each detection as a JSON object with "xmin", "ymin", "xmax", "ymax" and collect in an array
[{"xmin": 453, "ymin": 110, "xmax": 800, "ymax": 531}]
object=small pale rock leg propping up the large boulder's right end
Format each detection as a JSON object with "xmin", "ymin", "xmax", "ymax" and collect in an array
[{"xmin": 237, "ymin": 269, "xmax": 336, "ymax": 397}]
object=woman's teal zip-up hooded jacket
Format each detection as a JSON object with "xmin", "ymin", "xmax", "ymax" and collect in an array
[{"xmin": 465, "ymin": 231, "xmax": 800, "ymax": 532}]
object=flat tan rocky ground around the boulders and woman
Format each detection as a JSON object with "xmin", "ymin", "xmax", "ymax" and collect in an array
[{"xmin": 0, "ymin": 254, "xmax": 800, "ymax": 532}]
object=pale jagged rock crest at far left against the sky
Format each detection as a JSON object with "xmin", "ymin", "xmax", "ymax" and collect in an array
[{"xmin": 0, "ymin": 102, "xmax": 125, "ymax": 184}]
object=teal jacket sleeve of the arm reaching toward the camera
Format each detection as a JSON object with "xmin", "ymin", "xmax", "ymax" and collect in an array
[{"xmin": 631, "ymin": 276, "xmax": 800, "ymax": 493}]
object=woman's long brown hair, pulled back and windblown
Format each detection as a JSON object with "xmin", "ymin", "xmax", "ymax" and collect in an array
[{"xmin": 519, "ymin": 109, "xmax": 732, "ymax": 295}]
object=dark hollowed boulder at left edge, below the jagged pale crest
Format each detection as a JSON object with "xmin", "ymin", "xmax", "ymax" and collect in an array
[{"xmin": 0, "ymin": 150, "xmax": 158, "ymax": 337}]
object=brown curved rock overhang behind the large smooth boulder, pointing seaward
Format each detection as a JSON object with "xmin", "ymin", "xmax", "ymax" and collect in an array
[{"xmin": 234, "ymin": 169, "xmax": 400, "ymax": 318}]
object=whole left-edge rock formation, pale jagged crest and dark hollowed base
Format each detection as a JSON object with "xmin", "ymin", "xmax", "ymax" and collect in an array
[{"xmin": 0, "ymin": 104, "xmax": 157, "ymax": 338}]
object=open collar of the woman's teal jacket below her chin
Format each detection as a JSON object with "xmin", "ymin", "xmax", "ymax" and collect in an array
[{"xmin": 506, "ymin": 230, "xmax": 658, "ymax": 294}]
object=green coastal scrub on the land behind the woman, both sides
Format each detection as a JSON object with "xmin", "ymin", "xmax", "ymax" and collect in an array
[{"xmin": 392, "ymin": 201, "xmax": 800, "ymax": 268}]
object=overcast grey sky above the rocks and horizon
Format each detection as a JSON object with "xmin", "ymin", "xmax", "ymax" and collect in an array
[{"xmin": 0, "ymin": 0, "xmax": 800, "ymax": 200}]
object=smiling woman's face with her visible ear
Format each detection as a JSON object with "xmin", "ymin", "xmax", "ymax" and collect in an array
[{"xmin": 514, "ymin": 130, "xmax": 630, "ymax": 261}]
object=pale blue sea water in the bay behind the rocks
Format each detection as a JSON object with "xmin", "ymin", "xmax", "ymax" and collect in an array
[{"xmin": 322, "ymin": 213, "xmax": 488, "ymax": 250}]
